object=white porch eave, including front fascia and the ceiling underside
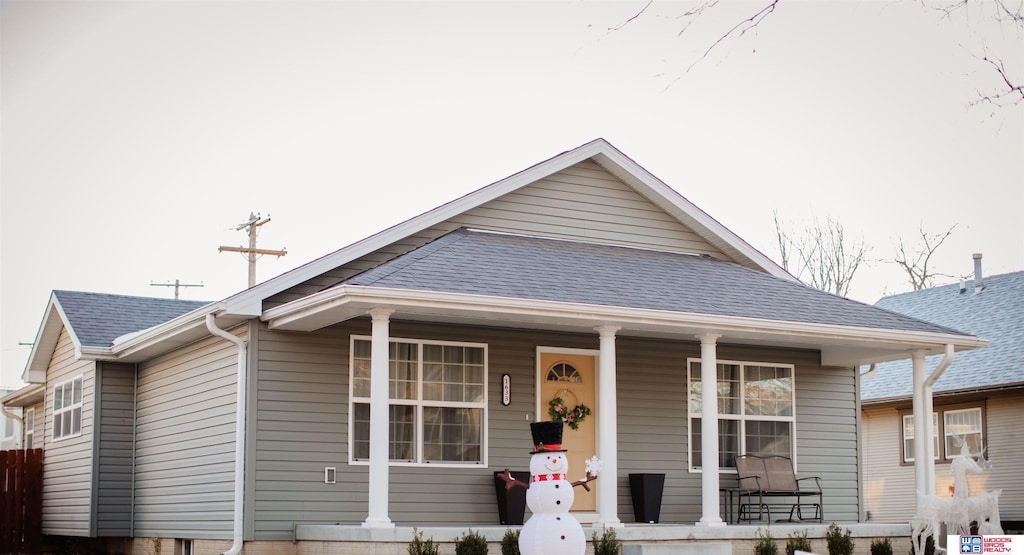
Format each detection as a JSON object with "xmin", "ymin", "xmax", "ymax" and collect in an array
[{"xmin": 261, "ymin": 285, "xmax": 987, "ymax": 367}]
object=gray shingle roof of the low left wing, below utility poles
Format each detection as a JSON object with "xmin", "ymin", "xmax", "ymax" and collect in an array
[{"xmin": 53, "ymin": 291, "xmax": 209, "ymax": 347}]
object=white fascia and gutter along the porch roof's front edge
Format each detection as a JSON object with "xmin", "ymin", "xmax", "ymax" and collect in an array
[{"xmin": 260, "ymin": 286, "xmax": 988, "ymax": 360}]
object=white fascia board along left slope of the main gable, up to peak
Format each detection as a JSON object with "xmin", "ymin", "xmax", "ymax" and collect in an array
[{"xmin": 225, "ymin": 138, "xmax": 634, "ymax": 317}]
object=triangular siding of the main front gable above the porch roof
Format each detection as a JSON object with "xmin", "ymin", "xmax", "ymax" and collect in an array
[{"xmin": 264, "ymin": 160, "xmax": 727, "ymax": 308}]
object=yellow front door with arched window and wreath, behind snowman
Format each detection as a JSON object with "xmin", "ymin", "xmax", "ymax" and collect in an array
[{"xmin": 538, "ymin": 349, "xmax": 600, "ymax": 512}]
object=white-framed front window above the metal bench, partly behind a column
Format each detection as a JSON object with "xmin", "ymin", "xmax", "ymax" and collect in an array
[{"xmin": 686, "ymin": 358, "xmax": 796, "ymax": 472}]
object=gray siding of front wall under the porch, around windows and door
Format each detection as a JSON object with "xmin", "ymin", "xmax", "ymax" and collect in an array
[{"xmin": 255, "ymin": 319, "xmax": 859, "ymax": 540}]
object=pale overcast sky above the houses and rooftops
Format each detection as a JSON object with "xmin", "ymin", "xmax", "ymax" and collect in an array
[{"xmin": 0, "ymin": 0, "xmax": 1024, "ymax": 384}]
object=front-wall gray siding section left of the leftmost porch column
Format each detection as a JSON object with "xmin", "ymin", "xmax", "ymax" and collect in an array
[{"xmin": 250, "ymin": 326, "xmax": 352, "ymax": 540}]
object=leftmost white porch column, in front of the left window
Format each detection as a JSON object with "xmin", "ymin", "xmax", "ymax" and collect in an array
[{"xmin": 362, "ymin": 308, "xmax": 394, "ymax": 528}]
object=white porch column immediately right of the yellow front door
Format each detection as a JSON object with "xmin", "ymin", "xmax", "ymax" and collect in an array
[{"xmin": 596, "ymin": 326, "xmax": 622, "ymax": 527}]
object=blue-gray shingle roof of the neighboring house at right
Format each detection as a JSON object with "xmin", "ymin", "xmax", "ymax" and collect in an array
[{"xmin": 861, "ymin": 271, "xmax": 1024, "ymax": 402}]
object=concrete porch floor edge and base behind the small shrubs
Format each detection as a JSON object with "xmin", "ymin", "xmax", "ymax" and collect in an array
[{"xmin": 295, "ymin": 522, "xmax": 910, "ymax": 555}]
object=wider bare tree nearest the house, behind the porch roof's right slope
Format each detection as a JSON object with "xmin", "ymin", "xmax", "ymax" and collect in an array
[{"xmin": 773, "ymin": 211, "xmax": 867, "ymax": 297}]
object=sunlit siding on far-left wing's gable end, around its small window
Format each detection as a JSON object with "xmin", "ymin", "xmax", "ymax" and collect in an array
[{"xmin": 41, "ymin": 330, "xmax": 95, "ymax": 537}]
